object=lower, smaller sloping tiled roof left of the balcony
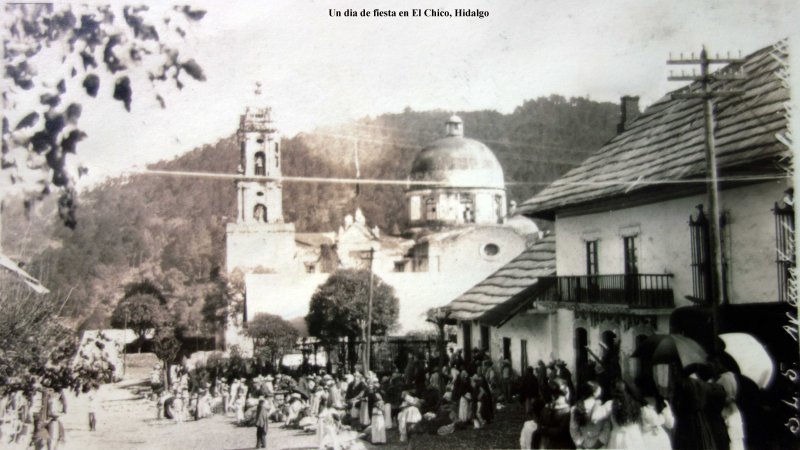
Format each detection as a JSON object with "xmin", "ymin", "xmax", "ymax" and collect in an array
[{"xmin": 446, "ymin": 234, "xmax": 556, "ymax": 320}]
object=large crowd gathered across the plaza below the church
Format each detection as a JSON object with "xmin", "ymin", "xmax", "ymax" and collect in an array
[{"xmin": 153, "ymin": 349, "xmax": 518, "ymax": 448}]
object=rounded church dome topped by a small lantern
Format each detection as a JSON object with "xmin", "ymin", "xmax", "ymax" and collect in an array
[{"xmin": 410, "ymin": 116, "xmax": 505, "ymax": 190}]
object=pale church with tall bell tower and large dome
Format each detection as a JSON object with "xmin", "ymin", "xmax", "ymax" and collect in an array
[{"xmin": 226, "ymin": 102, "xmax": 536, "ymax": 350}]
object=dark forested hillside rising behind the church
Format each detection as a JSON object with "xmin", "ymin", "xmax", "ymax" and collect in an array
[{"xmin": 3, "ymin": 96, "xmax": 619, "ymax": 332}]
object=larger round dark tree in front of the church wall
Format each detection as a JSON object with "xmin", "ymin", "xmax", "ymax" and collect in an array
[{"xmin": 306, "ymin": 269, "xmax": 400, "ymax": 370}]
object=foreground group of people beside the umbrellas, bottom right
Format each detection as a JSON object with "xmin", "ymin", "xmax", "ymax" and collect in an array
[{"xmin": 520, "ymin": 363, "xmax": 745, "ymax": 450}]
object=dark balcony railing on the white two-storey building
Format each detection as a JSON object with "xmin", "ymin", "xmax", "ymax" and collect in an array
[{"xmin": 539, "ymin": 273, "xmax": 675, "ymax": 308}]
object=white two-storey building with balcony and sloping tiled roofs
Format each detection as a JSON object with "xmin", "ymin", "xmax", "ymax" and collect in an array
[{"xmin": 448, "ymin": 40, "xmax": 797, "ymax": 388}]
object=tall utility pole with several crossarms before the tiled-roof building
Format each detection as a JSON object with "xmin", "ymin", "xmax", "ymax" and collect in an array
[{"xmin": 667, "ymin": 46, "xmax": 743, "ymax": 352}]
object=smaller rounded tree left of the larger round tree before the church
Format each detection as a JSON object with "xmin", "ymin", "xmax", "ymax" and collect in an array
[{"xmin": 245, "ymin": 313, "xmax": 299, "ymax": 366}]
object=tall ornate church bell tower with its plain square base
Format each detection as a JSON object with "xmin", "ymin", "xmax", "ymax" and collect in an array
[{"xmin": 226, "ymin": 85, "xmax": 297, "ymax": 273}]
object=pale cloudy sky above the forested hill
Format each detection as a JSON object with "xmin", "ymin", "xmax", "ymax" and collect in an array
[{"xmin": 1, "ymin": 0, "xmax": 800, "ymax": 190}]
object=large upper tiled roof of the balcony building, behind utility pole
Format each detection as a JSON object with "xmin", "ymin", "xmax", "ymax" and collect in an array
[{"xmin": 519, "ymin": 42, "xmax": 791, "ymax": 218}]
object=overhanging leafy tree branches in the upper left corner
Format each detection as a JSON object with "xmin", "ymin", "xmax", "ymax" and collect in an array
[{"xmin": 0, "ymin": 3, "xmax": 205, "ymax": 228}]
